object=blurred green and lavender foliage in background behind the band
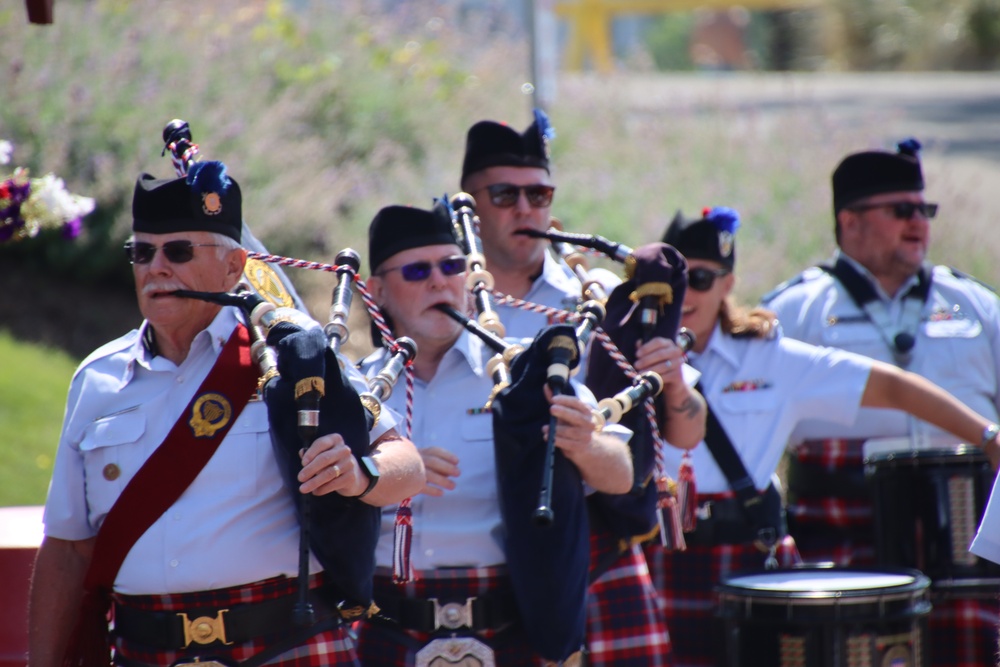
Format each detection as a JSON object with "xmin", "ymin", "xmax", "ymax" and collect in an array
[{"xmin": 0, "ymin": 0, "xmax": 1000, "ymax": 330}]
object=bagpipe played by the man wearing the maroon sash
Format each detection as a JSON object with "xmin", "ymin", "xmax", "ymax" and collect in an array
[{"xmin": 164, "ymin": 120, "xmax": 416, "ymax": 625}]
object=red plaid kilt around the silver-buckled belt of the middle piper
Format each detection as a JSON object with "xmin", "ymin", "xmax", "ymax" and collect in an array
[{"xmin": 358, "ymin": 567, "xmax": 542, "ymax": 667}]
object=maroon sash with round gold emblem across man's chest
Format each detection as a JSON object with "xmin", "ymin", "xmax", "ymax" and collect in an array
[{"xmin": 63, "ymin": 324, "xmax": 258, "ymax": 667}]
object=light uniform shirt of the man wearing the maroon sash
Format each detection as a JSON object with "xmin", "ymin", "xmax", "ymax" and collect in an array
[{"xmin": 44, "ymin": 308, "xmax": 396, "ymax": 595}]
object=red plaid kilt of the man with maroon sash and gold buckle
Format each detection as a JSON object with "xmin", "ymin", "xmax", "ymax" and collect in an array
[{"xmin": 113, "ymin": 575, "xmax": 360, "ymax": 667}]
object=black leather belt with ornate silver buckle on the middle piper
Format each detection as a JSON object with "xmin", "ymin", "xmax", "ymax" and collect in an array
[{"xmin": 376, "ymin": 595, "xmax": 519, "ymax": 633}]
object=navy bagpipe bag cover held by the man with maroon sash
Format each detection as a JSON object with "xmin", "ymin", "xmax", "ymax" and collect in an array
[{"xmin": 264, "ymin": 322, "xmax": 381, "ymax": 608}]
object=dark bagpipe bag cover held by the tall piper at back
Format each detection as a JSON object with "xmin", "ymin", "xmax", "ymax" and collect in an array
[{"xmin": 587, "ymin": 243, "xmax": 687, "ymax": 539}]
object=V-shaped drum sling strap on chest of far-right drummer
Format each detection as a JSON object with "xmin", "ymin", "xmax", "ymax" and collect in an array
[{"xmin": 819, "ymin": 257, "xmax": 932, "ymax": 368}]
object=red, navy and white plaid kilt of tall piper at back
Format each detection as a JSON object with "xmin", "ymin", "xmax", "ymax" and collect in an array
[{"xmin": 587, "ymin": 533, "xmax": 673, "ymax": 667}]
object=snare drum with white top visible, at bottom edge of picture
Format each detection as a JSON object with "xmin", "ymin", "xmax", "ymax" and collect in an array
[{"xmin": 716, "ymin": 567, "xmax": 931, "ymax": 667}]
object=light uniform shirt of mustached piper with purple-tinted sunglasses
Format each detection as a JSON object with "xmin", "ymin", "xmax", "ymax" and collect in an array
[{"xmin": 361, "ymin": 332, "xmax": 631, "ymax": 570}]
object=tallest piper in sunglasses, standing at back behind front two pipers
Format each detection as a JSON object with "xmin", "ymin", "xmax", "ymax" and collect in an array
[{"xmin": 461, "ymin": 115, "xmax": 704, "ymax": 667}]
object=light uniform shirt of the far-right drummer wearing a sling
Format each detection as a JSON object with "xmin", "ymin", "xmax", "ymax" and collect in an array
[{"xmin": 764, "ymin": 255, "xmax": 1000, "ymax": 448}]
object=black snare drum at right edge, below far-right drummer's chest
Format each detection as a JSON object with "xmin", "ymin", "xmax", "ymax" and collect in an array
[{"xmin": 865, "ymin": 445, "xmax": 1000, "ymax": 581}]
